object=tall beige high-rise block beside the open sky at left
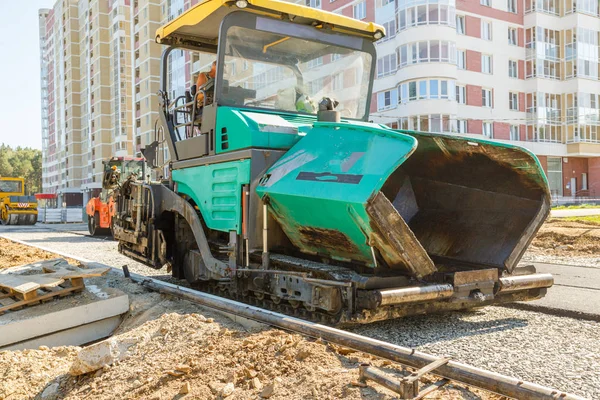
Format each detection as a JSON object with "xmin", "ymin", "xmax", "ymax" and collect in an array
[{"xmin": 39, "ymin": 0, "xmax": 133, "ymax": 205}]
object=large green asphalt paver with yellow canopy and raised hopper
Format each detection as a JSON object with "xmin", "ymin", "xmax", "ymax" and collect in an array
[{"xmin": 113, "ymin": 0, "xmax": 553, "ymax": 324}]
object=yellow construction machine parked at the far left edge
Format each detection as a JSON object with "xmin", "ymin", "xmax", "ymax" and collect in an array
[{"xmin": 0, "ymin": 177, "xmax": 38, "ymax": 225}]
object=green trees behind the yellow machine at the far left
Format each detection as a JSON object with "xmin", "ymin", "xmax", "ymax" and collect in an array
[{"xmin": 0, "ymin": 144, "xmax": 42, "ymax": 194}]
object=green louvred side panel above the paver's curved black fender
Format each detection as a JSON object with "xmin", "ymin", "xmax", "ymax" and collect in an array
[{"xmin": 173, "ymin": 160, "xmax": 250, "ymax": 233}]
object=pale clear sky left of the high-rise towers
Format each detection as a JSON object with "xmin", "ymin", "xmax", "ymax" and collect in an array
[{"xmin": 0, "ymin": 0, "xmax": 55, "ymax": 149}]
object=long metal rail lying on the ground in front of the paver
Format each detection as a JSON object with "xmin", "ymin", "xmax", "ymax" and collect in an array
[{"xmin": 131, "ymin": 274, "xmax": 585, "ymax": 400}]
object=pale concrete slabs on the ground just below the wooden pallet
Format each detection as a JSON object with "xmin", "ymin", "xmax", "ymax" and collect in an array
[{"xmin": 0, "ymin": 269, "xmax": 129, "ymax": 350}]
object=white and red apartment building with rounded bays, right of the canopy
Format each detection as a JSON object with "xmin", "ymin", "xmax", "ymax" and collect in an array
[{"xmin": 366, "ymin": 0, "xmax": 600, "ymax": 198}]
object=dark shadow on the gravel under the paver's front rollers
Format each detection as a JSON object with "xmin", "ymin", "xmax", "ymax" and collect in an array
[{"xmin": 347, "ymin": 311, "xmax": 528, "ymax": 348}]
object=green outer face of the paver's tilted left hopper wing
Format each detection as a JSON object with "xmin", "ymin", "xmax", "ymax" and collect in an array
[{"xmin": 257, "ymin": 123, "xmax": 417, "ymax": 266}]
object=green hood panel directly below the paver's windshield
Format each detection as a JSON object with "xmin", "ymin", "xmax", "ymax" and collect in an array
[{"xmin": 215, "ymin": 106, "xmax": 316, "ymax": 153}]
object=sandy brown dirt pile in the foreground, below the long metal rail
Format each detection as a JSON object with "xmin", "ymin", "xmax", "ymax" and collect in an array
[{"xmin": 0, "ymin": 313, "xmax": 501, "ymax": 400}]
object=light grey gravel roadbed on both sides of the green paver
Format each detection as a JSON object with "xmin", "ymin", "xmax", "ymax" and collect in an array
[{"xmin": 0, "ymin": 225, "xmax": 600, "ymax": 399}]
